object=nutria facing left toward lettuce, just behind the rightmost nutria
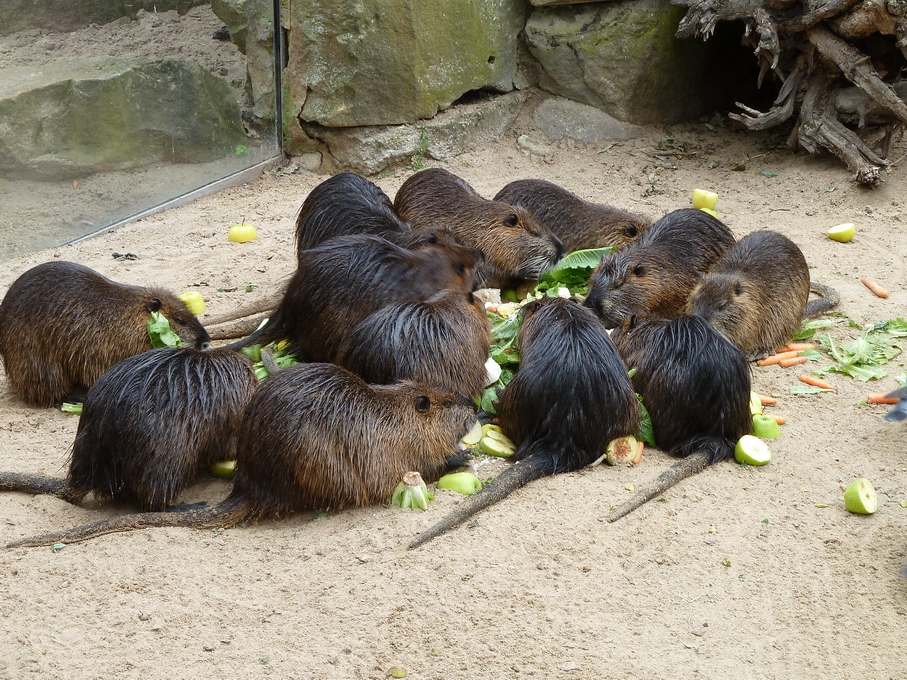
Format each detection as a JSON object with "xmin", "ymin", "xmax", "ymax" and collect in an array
[{"xmin": 584, "ymin": 208, "xmax": 734, "ymax": 328}]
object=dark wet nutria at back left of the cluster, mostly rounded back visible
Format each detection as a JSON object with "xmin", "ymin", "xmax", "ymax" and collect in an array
[{"xmin": 296, "ymin": 172, "xmax": 410, "ymax": 252}]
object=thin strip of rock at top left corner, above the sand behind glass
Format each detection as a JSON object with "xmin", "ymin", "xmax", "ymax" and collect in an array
[{"xmin": 0, "ymin": 0, "xmax": 210, "ymax": 35}]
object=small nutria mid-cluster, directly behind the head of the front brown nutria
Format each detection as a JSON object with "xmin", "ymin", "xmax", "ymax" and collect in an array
[{"xmin": 335, "ymin": 290, "xmax": 491, "ymax": 396}]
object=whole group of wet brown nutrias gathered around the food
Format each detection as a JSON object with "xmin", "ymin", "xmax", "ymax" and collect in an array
[{"xmin": 0, "ymin": 168, "xmax": 837, "ymax": 547}]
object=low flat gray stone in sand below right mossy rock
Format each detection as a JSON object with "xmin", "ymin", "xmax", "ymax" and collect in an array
[{"xmin": 532, "ymin": 97, "xmax": 641, "ymax": 145}]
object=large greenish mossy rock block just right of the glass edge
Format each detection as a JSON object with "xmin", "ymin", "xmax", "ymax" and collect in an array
[{"xmin": 283, "ymin": 0, "xmax": 527, "ymax": 130}]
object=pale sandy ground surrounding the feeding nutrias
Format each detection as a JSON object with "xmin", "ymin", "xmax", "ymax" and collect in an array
[{"xmin": 0, "ymin": 114, "xmax": 907, "ymax": 680}]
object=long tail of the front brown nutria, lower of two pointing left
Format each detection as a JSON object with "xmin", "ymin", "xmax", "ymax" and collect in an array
[{"xmin": 6, "ymin": 497, "xmax": 249, "ymax": 548}]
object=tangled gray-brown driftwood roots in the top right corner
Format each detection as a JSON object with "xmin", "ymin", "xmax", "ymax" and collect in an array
[{"xmin": 673, "ymin": 0, "xmax": 907, "ymax": 187}]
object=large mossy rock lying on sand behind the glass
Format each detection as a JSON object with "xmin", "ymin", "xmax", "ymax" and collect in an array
[{"xmin": 0, "ymin": 57, "xmax": 246, "ymax": 179}]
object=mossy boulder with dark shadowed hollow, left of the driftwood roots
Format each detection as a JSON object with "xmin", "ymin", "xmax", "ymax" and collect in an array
[{"xmin": 525, "ymin": 0, "xmax": 736, "ymax": 124}]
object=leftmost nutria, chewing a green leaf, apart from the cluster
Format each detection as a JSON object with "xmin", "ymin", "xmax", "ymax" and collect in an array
[{"xmin": 0, "ymin": 261, "xmax": 210, "ymax": 407}]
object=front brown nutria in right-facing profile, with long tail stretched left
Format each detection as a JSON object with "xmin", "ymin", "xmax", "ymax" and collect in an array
[{"xmin": 7, "ymin": 364, "xmax": 476, "ymax": 548}]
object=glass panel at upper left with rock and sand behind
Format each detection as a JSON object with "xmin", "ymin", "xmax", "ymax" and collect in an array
[{"xmin": 0, "ymin": 0, "xmax": 280, "ymax": 259}]
